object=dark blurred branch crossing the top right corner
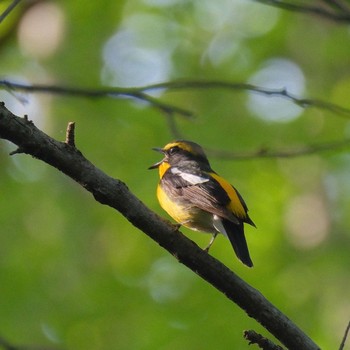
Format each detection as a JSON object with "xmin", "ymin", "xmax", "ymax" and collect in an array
[{"xmin": 254, "ymin": 0, "xmax": 350, "ymax": 23}]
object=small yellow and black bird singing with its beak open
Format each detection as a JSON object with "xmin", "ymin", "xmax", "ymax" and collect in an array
[{"xmin": 149, "ymin": 140, "xmax": 255, "ymax": 267}]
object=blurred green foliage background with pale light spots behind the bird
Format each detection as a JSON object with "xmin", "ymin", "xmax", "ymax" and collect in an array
[{"xmin": 0, "ymin": 0, "xmax": 350, "ymax": 350}]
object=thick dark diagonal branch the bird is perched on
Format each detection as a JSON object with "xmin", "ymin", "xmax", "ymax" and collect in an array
[{"xmin": 0, "ymin": 104, "xmax": 319, "ymax": 350}]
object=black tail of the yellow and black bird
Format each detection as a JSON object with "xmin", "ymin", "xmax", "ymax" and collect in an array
[{"xmin": 222, "ymin": 219, "xmax": 253, "ymax": 267}]
